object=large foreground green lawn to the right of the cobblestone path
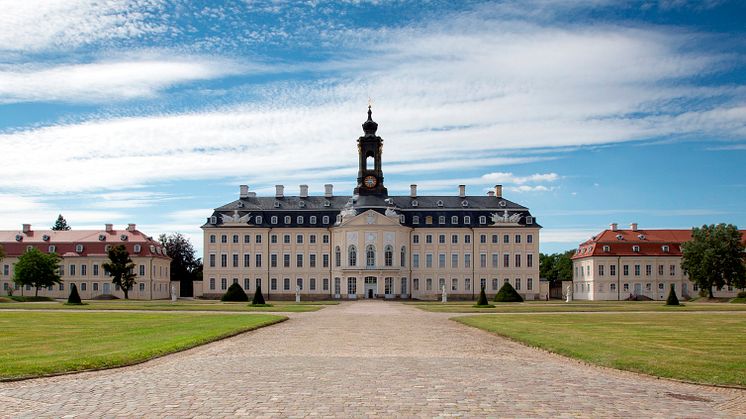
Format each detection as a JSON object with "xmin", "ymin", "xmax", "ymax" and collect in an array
[{"xmin": 454, "ymin": 313, "xmax": 746, "ymax": 386}]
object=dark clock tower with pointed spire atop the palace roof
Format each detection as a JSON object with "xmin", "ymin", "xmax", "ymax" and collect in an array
[{"xmin": 355, "ymin": 105, "xmax": 388, "ymax": 197}]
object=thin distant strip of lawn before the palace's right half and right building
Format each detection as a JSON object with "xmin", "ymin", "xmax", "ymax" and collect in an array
[{"xmin": 406, "ymin": 300, "xmax": 746, "ymax": 313}]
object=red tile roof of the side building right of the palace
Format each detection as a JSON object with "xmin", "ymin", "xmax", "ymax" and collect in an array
[{"xmin": 572, "ymin": 229, "xmax": 746, "ymax": 259}]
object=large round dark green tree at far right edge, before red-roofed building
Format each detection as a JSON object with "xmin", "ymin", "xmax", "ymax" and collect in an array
[{"xmin": 681, "ymin": 224, "xmax": 746, "ymax": 298}]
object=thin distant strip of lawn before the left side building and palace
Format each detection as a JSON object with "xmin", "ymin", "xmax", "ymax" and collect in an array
[{"xmin": 0, "ymin": 300, "xmax": 332, "ymax": 312}]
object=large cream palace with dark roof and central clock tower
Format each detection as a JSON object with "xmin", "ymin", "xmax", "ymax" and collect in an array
[{"xmin": 195, "ymin": 107, "xmax": 541, "ymax": 299}]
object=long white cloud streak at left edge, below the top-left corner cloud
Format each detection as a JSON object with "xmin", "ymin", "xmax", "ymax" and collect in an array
[{"xmin": 0, "ymin": 57, "xmax": 247, "ymax": 103}]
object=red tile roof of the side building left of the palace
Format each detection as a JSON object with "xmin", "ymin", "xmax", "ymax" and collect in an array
[{"xmin": 0, "ymin": 225, "xmax": 168, "ymax": 259}]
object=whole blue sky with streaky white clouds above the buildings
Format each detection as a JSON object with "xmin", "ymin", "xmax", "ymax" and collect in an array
[{"xmin": 0, "ymin": 0, "xmax": 746, "ymax": 252}]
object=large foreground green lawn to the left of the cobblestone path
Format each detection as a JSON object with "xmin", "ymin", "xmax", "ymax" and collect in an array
[{"xmin": 0, "ymin": 311, "xmax": 287, "ymax": 379}]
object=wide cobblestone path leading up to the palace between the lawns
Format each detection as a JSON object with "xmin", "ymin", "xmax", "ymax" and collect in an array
[{"xmin": 0, "ymin": 301, "xmax": 746, "ymax": 418}]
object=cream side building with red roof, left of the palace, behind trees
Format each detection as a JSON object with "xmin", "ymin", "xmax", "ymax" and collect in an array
[{"xmin": 0, "ymin": 224, "xmax": 171, "ymax": 300}]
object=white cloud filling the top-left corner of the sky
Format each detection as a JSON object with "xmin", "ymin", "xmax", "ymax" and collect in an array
[{"xmin": 0, "ymin": 0, "xmax": 168, "ymax": 52}]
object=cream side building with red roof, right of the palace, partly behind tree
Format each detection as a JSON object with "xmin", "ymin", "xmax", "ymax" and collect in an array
[{"xmin": 572, "ymin": 224, "xmax": 746, "ymax": 300}]
